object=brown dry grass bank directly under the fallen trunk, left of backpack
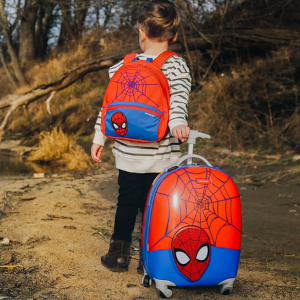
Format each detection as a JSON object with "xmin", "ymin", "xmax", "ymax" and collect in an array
[{"xmin": 4, "ymin": 72, "xmax": 108, "ymax": 138}]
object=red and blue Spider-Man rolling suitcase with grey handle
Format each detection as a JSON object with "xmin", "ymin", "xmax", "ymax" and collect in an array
[{"xmin": 142, "ymin": 130, "xmax": 242, "ymax": 298}]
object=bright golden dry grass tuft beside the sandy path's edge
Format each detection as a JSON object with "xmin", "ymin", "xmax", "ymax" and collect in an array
[{"xmin": 28, "ymin": 128, "xmax": 92, "ymax": 170}]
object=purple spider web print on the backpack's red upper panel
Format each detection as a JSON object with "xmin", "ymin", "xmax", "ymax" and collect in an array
[{"xmin": 112, "ymin": 70, "xmax": 159, "ymax": 108}]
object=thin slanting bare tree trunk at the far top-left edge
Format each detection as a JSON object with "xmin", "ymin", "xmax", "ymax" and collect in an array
[{"xmin": 0, "ymin": 0, "xmax": 27, "ymax": 85}]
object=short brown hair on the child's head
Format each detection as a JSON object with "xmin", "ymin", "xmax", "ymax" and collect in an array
[{"xmin": 137, "ymin": 0, "xmax": 181, "ymax": 44}]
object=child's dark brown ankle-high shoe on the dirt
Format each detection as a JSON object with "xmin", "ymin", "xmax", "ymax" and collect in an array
[{"xmin": 101, "ymin": 239, "xmax": 131, "ymax": 272}]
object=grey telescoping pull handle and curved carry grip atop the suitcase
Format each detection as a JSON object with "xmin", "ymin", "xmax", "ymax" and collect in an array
[{"xmin": 165, "ymin": 130, "xmax": 212, "ymax": 171}]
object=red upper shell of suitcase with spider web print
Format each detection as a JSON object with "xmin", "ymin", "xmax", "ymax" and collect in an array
[{"xmin": 149, "ymin": 167, "xmax": 241, "ymax": 250}]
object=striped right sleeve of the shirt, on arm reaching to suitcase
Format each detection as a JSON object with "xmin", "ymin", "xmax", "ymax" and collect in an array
[{"xmin": 162, "ymin": 56, "xmax": 191, "ymax": 132}]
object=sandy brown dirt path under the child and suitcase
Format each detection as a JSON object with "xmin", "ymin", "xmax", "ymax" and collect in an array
[{"xmin": 0, "ymin": 165, "xmax": 300, "ymax": 300}]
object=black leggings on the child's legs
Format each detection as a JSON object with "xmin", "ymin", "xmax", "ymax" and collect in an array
[{"xmin": 112, "ymin": 170, "xmax": 159, "ymax": 242}]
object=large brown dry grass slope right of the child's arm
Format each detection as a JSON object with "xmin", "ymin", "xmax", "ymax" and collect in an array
[{"xmin": 189, "ymin": 49, "xmax": 300, "ymax": 149}]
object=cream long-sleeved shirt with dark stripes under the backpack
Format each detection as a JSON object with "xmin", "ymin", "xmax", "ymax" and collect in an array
[{"xmin": 93, "ymin": 54, "xmax": 191, "ymax": 173}]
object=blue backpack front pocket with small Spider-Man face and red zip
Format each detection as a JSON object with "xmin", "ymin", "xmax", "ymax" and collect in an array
[{"xmin": 105, "ymin": 102, "xmax": 163, "ymax": 142}]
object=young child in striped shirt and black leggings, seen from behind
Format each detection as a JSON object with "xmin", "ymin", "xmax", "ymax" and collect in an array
[{"xmin": 91, "ymin": 0, "xmax": 191, "ymax": 272}]
